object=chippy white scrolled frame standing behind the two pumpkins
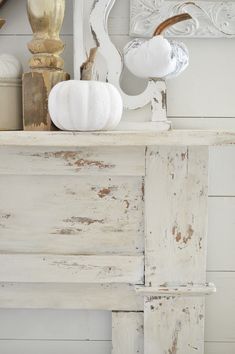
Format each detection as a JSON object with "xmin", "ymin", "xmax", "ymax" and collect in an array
[{"xmin": 74, "ymin": 0, "xmax": 170, "ymax": 131}]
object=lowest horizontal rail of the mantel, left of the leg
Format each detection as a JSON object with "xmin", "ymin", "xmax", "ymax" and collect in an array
[{"xmin": 0, "ymin": 283, "xmax": 143, "ymax": 310}]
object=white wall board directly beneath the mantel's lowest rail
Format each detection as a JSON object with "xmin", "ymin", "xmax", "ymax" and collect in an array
[{"xmin": 0, "ymin": 309, "xmax": 112, "ymax": 341}]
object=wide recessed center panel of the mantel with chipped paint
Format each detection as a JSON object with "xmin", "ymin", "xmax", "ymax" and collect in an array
[{"xmin": 0, "ymin": 176, "xmax": 144, "ymax": 255}]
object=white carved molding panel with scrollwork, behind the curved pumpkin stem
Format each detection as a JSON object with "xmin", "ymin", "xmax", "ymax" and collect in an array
[{"xmin": 130, "ymin": 0, "xmax": 235, "ymax": 38}]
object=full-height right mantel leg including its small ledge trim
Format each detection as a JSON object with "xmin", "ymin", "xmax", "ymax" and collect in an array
[{"xmin": 143, "ymin": 147, "xmax": 213, "ymax": 354}]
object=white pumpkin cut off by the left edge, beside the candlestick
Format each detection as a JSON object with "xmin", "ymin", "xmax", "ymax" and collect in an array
[{"xmin": 0, "ymin": 54, "xmax": 23, "ymax": 79}]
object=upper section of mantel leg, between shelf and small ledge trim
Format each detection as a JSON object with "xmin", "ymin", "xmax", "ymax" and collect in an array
[{"xmin": 145, "ymin": 147, "xmax": 208, "ymax": 286}]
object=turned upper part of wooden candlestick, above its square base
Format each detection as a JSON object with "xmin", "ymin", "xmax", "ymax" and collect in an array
[{"xmin": 27, "ymin": 0, "xmax": 65, "ymax": 70}]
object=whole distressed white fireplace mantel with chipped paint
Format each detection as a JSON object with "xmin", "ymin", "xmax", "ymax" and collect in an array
[{"xmin": 0, "ymin": 129, "xmax": 235, "ymax": 354}]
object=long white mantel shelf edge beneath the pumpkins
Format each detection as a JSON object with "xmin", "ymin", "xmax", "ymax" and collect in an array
[{"xmin": 0, "ymin": 129, "xmax": 235, "ymax": 147}]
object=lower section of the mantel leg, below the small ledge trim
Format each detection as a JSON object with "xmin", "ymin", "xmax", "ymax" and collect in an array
[{"xmin": 144, "ymin": 296, "xmax": 204, "ymax": 354}]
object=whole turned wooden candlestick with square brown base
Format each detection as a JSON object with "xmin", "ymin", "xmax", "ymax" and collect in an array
[{"xmin": 23, "ymin": 0, "xmax": 69, "ymax": 130}]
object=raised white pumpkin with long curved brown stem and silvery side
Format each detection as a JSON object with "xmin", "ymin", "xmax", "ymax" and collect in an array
[{"xmin": 124, "ymin": 14, "xmax": 191, "ymax": 78}]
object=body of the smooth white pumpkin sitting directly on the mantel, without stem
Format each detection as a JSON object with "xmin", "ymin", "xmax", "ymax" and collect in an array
[{"xmin": 49, "ymin": 80, "xmax": 123, "ymax": 131}]
